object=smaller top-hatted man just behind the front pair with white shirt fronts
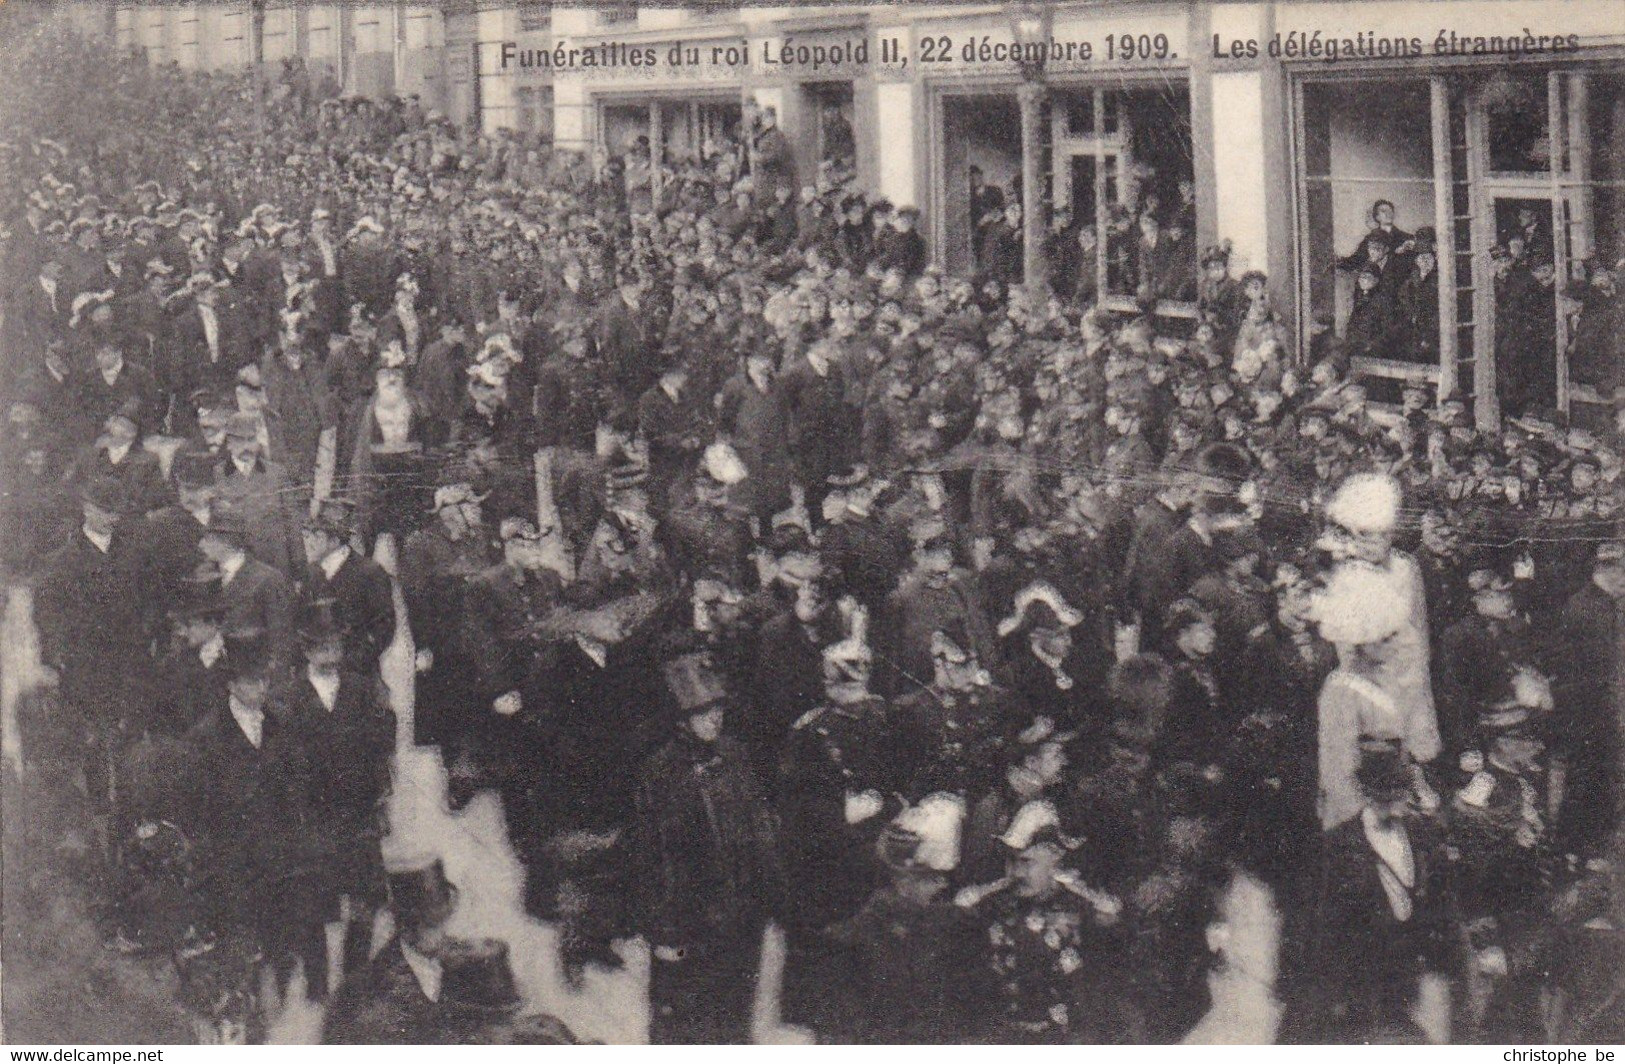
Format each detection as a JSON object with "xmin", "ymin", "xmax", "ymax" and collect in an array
[{"xmin": 301, "ymin": 499, "xmax": 395, "ymax": 677}]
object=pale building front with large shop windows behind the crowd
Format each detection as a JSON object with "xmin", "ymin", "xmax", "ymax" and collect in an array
[{"xmin": 95, "ymin": 0, "xmax": 1625, "ymax": 419}]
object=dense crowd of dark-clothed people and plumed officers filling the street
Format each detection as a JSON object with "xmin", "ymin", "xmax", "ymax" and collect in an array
[{"xmin": 0, "ymin": 14, "xmax": 1625, "ymax": 1041}]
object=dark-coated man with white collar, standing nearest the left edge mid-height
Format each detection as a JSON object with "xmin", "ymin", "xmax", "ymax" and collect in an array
[{"xmin": 34, "ymin": 478, "xmax": 150, "ymax": 804}]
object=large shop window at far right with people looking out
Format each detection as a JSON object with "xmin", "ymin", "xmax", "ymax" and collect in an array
[{"xmin": 1298, "ymin": 65, "xmax": 1625, "ymax": 424}]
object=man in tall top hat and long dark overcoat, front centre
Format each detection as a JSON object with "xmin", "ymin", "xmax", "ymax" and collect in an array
[{"xmin": 627, "ymin": 653, "xmax": 783, "ymax": 1045}]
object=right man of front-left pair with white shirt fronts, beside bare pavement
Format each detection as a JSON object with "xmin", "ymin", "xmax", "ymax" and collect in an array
[{"xmin": 271, "ymin": 601, "xmax": 395, "ymax": 996}]
